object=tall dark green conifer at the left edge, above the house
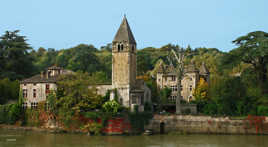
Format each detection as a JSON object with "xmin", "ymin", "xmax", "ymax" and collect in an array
[{"xmin": 0, "ymin": 30, "xmax": 33, "ymax": 80}]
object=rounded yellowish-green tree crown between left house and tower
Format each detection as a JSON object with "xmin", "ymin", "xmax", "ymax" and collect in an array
[{"xmin": 56, "ymin": 72, "xmax": 102, "ymax": 112}]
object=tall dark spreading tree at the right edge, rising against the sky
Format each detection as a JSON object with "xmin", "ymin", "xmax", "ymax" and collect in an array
[{"xmin": 233, "ymin": 31, "xmax": 268, "ymax": 84}]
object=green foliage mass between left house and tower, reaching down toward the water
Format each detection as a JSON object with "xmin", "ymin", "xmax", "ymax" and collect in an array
[{"xmin": 51, "ymin": 72, "xmax": 104, "ymax": 124}]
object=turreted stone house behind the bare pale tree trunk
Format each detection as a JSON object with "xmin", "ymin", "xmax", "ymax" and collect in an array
[{"xmin": 156, "ymin": 63, "xmax": 209, "ymax": 102}]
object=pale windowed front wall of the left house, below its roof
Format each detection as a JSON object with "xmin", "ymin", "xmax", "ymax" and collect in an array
[{"xmin": 20, "ymin": 83, "xmax": 57, "ymax": 107}]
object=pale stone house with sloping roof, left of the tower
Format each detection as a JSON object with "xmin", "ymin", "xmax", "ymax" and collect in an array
[{"xmin": 20, "ymin": 66, "xmax": 73, "ymax": 108}]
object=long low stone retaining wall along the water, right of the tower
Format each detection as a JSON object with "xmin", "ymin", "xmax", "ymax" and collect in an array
[{"xmin": 145, "ymin": 115, "xmax": 268, "ymax": 134}]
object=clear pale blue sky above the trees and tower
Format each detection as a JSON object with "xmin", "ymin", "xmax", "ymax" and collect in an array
[{"xmin": 0, "ymin": 0, "xmax": 268, "ymax": 51}]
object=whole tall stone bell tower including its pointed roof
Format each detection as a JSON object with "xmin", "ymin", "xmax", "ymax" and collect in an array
[{"xmin": 112, "ymin": 16, "xmax": 137, "ymax": 107}]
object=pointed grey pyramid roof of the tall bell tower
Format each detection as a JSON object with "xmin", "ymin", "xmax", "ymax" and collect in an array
[{"xmin": 113, "ymin": 16, "xmax": 136, "ymax": 44}]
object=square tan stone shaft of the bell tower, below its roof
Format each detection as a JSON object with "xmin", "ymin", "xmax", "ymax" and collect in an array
[{"xmin": 112, "ymin": 43, "xmax": 137, "ymax": 107}]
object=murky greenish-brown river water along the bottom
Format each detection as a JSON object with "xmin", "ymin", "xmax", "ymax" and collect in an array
[{"xmin": 0, "ymin": 130, "xmax": 268, "ymax": 147}]
